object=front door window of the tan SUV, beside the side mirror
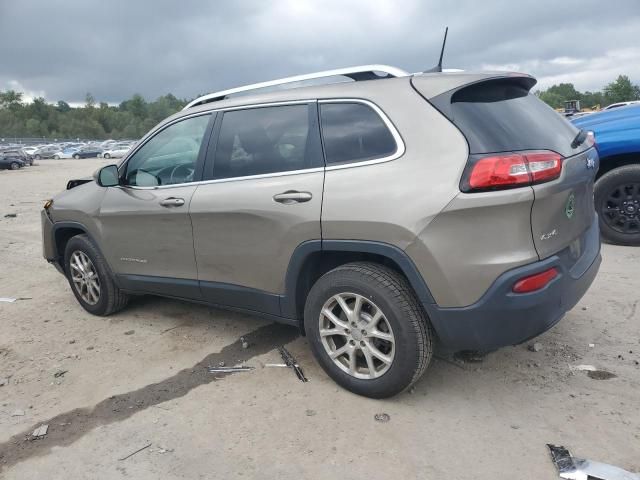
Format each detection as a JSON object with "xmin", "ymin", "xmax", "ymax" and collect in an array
[{"xmin": 125, "ymin": 115, "xmax": 209, "ymax": 187}]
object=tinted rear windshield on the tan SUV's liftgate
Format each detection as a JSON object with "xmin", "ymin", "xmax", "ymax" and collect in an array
[{"xmin": 433, "ymin": 80, "xmax": 586, "ymax": 156}]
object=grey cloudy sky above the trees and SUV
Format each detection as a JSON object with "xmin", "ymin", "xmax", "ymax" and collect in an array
[{"xmin": 0, "ymin": 0, "xmax": 640, "ymax": 103}]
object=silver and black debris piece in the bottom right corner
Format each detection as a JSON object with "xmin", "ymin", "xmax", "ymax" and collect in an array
[{"xmin": 547, "ymin": 444, "xmax": 640, "ymax": 480}]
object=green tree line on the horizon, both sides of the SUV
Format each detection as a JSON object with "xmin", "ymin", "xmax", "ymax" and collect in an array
[{"xmin": 0, "ymin": 75, "xmax": 640, "ymax": 140}]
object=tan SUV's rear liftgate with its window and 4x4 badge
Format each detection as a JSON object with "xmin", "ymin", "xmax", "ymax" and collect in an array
[{"xmin": 433, "ymin": 77, "xmax": 598, "ymax": 259}]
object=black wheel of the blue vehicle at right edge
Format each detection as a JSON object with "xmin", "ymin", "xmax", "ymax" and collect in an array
[{"xmin": 594, "ymin": 165, "xmax": 640, "ymax": 246}]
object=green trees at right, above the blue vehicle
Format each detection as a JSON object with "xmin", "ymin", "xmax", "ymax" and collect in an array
[{"xmin": 535, "ymin": 75, "xmax": 640, "ymax": 109}]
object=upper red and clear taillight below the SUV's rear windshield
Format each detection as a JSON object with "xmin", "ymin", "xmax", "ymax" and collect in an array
[{"xmin": 460, "ymin": 150, "xmax": 563, "ymax": 192}]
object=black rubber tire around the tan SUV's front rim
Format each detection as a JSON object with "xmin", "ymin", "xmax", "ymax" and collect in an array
[{"xmin": 64, "ymin": 235, "xmax": 129, "ymax": 316}]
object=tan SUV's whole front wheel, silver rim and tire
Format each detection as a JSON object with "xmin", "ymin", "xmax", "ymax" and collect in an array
[{"xmin": 64, "ymin": 235, "xmax": 129, "ymax": 315}]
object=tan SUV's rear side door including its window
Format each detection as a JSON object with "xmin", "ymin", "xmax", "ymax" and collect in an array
[{"xmin": 190, "ymin": 102, "xmax": 324, "ymax": 314}]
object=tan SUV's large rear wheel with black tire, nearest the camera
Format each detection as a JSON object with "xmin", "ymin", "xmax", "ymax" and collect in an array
[{"xmin": 304, "ymin": 262, "xmax": 433, "ymax": 398}]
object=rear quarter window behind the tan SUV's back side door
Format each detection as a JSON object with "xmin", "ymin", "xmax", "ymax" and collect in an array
[{"xmin": 320, "ymin": 103, "xmax": 396, "ymax": 165}]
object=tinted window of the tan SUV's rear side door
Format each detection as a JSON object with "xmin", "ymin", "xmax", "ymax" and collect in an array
[{"xmin": 213, "ymin": 105, "xmax": 317, "ymax": 179}]
